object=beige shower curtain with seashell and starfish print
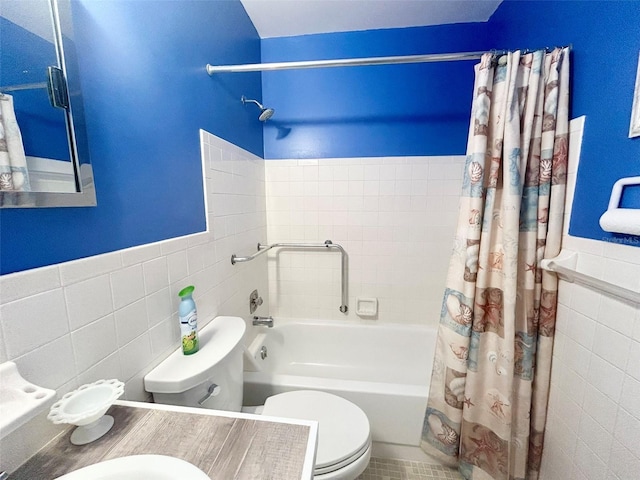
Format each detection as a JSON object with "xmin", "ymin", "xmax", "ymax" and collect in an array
[{"xmin": 421, "ymin": 48, "xmax": 569, "ymax": 480}]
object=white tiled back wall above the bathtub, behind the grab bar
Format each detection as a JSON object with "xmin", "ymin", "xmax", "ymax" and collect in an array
[{"xmin": 266, "ymin": 156, "xmax": 465, "ymax": 326}]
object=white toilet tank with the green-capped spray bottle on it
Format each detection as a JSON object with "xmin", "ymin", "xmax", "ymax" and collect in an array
[{"xmin": 144, "ymin": 317, "xmax": 246, "ymax": 412}]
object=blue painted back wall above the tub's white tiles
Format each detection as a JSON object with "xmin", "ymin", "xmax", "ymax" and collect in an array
[{"xmin": 262, "ymin": 23, "xmax": 493, "ymax": 158}]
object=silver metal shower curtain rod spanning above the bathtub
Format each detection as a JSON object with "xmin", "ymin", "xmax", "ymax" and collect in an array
[{"xmin": 207, "ymin": 50, "xmax": 498, "ymax": 75}]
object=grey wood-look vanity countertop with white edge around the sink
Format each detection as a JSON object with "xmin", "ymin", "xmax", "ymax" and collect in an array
[{"xmin": 9, "ymin": 401, "xmax": 318, "ymax": 480}]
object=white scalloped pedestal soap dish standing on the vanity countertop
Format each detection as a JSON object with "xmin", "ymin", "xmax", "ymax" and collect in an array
[{"xmin": 47, "ymin": 379, "xmax": 124, "ymax": 445}]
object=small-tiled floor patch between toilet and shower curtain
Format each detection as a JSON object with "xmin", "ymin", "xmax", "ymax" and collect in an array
[{"xmin": 357, "ymin": 457, "xmax": 462, "ymax": 480}]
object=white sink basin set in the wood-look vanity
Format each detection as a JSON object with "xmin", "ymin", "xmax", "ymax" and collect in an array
[{"xmin": 55, "ymin": 455, "xmax": 210, "ymax": 480}]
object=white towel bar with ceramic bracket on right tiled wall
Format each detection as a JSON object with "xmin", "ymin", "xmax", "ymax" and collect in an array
[{"xmin": 540, "ymin": 250, "xmax": 640, "ymax": 303}]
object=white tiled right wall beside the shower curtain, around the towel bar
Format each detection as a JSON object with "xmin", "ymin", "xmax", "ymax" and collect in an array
[{"xmin": 541, "ymin": 119, "xmax": 640, "ymax": 480}]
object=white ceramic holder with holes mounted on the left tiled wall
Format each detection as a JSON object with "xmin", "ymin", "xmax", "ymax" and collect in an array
[{"xmin": 0, "ymin": 362, "xmax": 56, "ymax": 438}]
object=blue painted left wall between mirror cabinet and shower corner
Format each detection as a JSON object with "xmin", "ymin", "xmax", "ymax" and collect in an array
[{"xmin": 0, "ymin": 0, "xmax": 263, "ymax": 274}]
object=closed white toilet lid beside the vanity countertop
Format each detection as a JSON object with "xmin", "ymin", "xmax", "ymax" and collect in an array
[{"xmin": 262, "ymin": 390, "xmax": 370, "ymax": 471}]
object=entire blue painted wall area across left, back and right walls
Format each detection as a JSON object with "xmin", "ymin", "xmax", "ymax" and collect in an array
[{"xmin": 0, "ymin": 0, "xmax": 640, "ymax": 273}]
